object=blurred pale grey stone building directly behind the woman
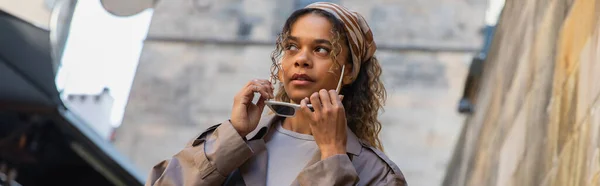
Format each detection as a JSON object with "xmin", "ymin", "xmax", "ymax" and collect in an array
[{"xmin": 111, "ymin": 0, "xmax": 487, "ymax": 186}]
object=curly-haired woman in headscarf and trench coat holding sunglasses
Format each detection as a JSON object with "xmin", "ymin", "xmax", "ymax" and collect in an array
[{"xmin": 146, "ymin": 3, "xmax": 406, "ymax": 185}]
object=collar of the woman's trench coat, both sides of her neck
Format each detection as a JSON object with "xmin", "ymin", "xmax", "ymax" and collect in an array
[{"xmin": 246, "ymin": 114, "xmax": 362, "ymax": 156}]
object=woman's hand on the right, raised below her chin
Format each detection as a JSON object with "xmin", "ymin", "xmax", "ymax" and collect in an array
[{"xmin": 300, "ymin": 89, "xmax": 347, "ymax": 160}]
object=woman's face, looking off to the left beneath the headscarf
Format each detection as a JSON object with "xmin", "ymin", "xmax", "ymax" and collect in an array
[{"xmin": 279, "ymin": 13, "xmax": 351, "ymax": 103}]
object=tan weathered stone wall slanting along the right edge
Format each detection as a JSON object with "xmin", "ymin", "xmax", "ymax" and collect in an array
[{"xmin": 444, "ymin": 0, "xmax": 600, "ymax": 186}]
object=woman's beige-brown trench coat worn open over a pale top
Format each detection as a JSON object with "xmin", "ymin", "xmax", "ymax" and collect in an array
[{"xmin": 146, "ymin": 115, "xmax": 407, "ymax": 186}]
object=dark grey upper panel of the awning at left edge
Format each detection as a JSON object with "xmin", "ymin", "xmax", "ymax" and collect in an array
[{"xmin": 0, "ymin": 11, "xmax": 61, "ymax": 107}]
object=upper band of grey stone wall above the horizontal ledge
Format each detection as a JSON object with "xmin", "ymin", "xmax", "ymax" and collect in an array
[{"xmin": 148, "ymin": 0, "xmax": 486, "ymax": 47}]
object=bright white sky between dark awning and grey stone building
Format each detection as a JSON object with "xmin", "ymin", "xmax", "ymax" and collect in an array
[{"xmin": 56, "ymin": 0, "xmax": 152, "ymax": 126}]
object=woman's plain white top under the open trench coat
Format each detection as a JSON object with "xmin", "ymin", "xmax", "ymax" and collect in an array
[{"xmin": 266, "ymin": 122, "xmax": 319, "ymax": 186}]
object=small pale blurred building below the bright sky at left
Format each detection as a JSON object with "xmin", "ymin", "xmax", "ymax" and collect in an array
[{"xmin": 63, "ymin": 88, "xmax": 114, "ymax": 140}]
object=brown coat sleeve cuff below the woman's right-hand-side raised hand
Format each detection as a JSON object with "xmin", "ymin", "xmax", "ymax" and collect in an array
[{"xmin": 297, "ymin": 154, "xmax": 358, "ymax": 185}]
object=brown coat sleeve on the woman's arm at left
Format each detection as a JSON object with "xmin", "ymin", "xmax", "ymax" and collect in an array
[{"xmin": 146, "ymin": 121, "xmax": 253, "ymax": 185}]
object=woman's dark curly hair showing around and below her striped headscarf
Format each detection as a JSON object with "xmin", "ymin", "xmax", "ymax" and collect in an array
[{"xmin": 270, "ymin": 8, "xmax": 386, "ymax": 150}]
